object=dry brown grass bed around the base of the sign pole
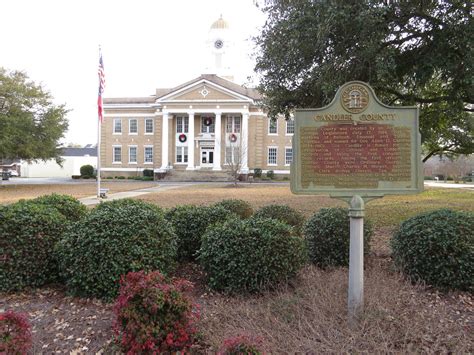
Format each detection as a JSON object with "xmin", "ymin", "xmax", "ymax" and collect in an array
[{"xmin": 199, "ymin": 259, "xmax": 474, "ymax": 353}]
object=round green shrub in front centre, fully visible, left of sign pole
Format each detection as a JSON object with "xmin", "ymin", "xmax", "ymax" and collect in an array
[{"xmin": 199, "ymin": 218, "xmax": 306, "ymax": 293}]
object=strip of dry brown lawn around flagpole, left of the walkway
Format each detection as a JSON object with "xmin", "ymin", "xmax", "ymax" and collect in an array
[{"xmin": 0, "ymin": 181, "xmax": 156, "ymax": 204}]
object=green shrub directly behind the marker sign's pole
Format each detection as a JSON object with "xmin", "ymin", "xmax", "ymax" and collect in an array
[{"xmin": 303, "ymin": 207, "xmax": 373, "ymax": 268}]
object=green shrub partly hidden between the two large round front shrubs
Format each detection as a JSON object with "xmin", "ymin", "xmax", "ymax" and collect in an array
[{"xmin": 165, "ymin": 205, "xmax": 234, "ymax": 260}]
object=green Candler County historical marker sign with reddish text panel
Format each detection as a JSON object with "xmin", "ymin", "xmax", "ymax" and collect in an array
[{"xmin": 291, "ymin": 81, "xmax": 423, "ymax": 198}]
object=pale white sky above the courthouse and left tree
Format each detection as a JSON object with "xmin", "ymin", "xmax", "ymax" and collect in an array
[{"xmin": 0, "ymin": 0, "xmax": 266, "ymax": 144}]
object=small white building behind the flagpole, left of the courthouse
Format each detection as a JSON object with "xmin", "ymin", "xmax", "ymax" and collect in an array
[{"xmin": 21, "ymin": 146, "xmax": 97, "ymax": 178}]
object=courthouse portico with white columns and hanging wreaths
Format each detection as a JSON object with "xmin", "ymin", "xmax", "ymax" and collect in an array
[{"xmin": 155, "ymin": 105, "xmax": 249, "ymax": 174}]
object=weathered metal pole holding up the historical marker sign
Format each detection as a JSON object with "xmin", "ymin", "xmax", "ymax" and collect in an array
[{"xmin": 348, "ymin": 195, "xmax": 365, "ymax": 325}]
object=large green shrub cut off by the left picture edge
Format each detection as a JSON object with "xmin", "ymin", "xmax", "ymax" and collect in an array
[{"xmin": 0, "ymin": 201, "xmax": 68, "ymax": 291}]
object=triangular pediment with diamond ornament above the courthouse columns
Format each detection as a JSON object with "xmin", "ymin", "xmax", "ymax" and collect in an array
[{"xmin": 158, "ymin": 82, "xmax": 249, "ymax": 102}]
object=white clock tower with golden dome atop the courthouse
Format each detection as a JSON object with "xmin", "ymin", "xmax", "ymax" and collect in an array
[{"xmin": 206, "ymin": 15, "xmax": 234, "ymax": 81}]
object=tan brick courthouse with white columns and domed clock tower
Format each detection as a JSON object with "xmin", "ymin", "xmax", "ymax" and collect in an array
[{"xmin": 100, "ymin": 17, "xmax": 294, "ymax": 177}]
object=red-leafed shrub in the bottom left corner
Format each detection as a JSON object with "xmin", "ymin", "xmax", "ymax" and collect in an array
[{"xmin": 0, "ymin": 311, "xmax": 31, "ymax": 354}]
